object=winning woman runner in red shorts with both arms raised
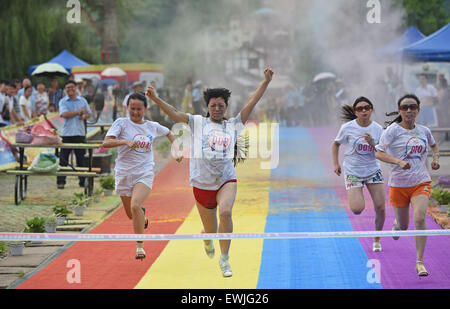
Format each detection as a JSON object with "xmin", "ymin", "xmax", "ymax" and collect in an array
[{"xmin": 147, "ymin": 68, "xmax": 273, "ymax": 277}]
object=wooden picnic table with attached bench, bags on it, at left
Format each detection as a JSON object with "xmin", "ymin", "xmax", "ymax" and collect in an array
[{"xmin": 6, "ymin": 143, "xmax": 102, "ymax": 205}]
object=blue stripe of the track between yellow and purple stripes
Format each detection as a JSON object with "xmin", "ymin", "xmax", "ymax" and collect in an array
[{"xmin": 257, "ymin": 128, "xmax": 381, "ymax": 289}]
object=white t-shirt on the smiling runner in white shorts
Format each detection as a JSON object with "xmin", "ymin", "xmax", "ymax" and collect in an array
[{"xmin": 106, "ymin": 118, "xmax": 170, "ymax": 175}]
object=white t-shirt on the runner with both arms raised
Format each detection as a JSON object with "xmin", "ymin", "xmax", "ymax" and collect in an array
[{"xmin": 187, "ymin": 114, "xmax": 245, "ymax": 190}]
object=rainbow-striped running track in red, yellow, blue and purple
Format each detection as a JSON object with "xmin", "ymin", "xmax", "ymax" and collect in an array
[{"xmin": 14, "ymin": 128, "xmax": 450, "ymax": 289}]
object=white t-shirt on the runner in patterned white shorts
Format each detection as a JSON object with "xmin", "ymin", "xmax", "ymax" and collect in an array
[{"xmin": 335, "ymin": 119, "xmax": 383, "ymax": 178}]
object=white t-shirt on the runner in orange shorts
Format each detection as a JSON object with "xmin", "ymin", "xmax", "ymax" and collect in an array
[{"xmin": 376, "ymin": 122, "xmax": 436, "ymax": 188}]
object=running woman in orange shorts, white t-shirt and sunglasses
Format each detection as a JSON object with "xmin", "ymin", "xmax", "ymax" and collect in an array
[{"xmin": 376, "ymin": 94, "xmax": 440, "ymax": 276}]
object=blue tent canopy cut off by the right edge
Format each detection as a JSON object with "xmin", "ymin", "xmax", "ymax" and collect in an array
[{"xmin": 403, "ymin": 24, "xmax": 450, "ymax": 62}]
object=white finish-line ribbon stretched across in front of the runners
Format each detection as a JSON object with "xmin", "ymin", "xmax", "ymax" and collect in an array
[{"xmin": 0, "ymin": 230, "xmax": 450, "ymax": 241}]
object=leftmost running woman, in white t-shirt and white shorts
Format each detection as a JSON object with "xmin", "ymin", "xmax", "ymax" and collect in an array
[{"xmin": 103, "ymin": 93, "xmax": 182, "ymax": 260}]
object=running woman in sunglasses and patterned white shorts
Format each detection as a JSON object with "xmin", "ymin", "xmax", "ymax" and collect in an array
[{"xmin": 332, "ymin": 97, "xmax": 386, "ymax": 252}]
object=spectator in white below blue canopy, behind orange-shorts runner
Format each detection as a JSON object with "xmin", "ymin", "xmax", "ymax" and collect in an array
[{"xmin": 415, "ymin": 74, "xmax": 438, "ymax": 127}]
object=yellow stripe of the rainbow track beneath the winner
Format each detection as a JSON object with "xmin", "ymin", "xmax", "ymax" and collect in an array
[{"xmin": 135, "ymin": 126, "xmax": 270, "ymax": 289}]
